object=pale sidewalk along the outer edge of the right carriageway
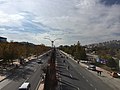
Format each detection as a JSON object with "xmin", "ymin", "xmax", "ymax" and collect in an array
[{"xmin": 62, "ymin": 51, "xmax": 120, "ymax": 90}]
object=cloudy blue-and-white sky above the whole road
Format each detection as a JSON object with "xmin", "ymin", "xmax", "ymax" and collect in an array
[{"xmin": 0, "ymin": 0, "xmax": 120, "ymax": 46}]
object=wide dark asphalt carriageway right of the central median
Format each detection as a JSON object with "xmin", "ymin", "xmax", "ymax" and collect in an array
[{"xmin": 56, "ymin": 51, "xmax": 113, "ymax": 90}]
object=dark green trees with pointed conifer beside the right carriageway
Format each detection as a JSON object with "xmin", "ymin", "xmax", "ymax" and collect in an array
[{"xmin": 59, "ymin": 41, "xmax": 87, "ymax": 60}]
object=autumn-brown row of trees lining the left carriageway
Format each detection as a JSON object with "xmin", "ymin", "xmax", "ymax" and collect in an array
[{"xmin": 0, "ymin": 42, "xmax": 50, "ymax": 65}]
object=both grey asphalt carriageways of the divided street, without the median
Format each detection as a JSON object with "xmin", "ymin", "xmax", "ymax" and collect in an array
[{"xmin": 0, "ymin": 50, "xmax": 119, "ymax": 90}]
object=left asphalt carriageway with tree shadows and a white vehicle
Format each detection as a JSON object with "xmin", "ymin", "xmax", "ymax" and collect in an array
[{"xmin": 0, "ymin": 51, "xmax": 50, "ymax": 90}]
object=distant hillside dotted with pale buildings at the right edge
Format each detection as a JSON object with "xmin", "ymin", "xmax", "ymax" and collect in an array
[{"xmin": 85, "ymin": 40, "xmax": 120, "ymax": 59}]
